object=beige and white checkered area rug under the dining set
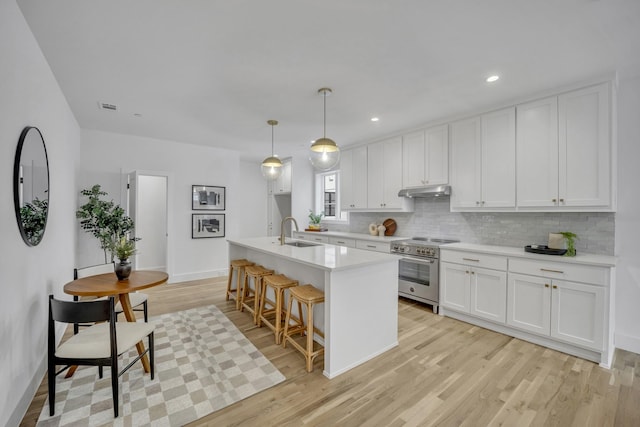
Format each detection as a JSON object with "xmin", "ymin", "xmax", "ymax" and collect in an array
[{"xmin": 37, "ymin": 306, "xmax": 285, "ymax": 427}]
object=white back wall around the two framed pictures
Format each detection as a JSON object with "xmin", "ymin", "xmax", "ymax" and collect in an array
[{"xmin": 78, "ymin": 129, "xmax": 266, "ymax": 282}]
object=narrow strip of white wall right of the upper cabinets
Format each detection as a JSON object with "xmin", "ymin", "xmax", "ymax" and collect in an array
[{"xmin": 614, "ymin": 72, "xmax": 640, "ymax": 353}]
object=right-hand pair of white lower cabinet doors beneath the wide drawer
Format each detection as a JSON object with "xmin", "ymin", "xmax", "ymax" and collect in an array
[{"xmin": 507, "ymin": 273, "xmax": 605, "ymax": 351}]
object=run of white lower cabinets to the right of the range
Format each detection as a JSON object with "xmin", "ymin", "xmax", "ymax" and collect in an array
[{"xmin": 440, "ymin": 245, "xmax": 615, "ymax": 368}]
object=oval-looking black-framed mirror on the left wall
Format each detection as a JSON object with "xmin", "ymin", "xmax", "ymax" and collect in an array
[{"xmin": 13, "ymin": 127, "xmax": 49, "ymax": 246}]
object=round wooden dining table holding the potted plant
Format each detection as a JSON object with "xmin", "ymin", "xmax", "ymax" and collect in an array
[{"xmin": 64, "ymin": 270, "xmax": 169, "ymax": 372}]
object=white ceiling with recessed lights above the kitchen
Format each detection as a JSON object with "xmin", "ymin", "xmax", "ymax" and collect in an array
[{"xmin": 18, "ymin": 0, "xmax": 640, "ymax": 161}]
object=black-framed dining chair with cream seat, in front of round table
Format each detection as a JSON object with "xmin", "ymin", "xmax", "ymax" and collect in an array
[{"xmin": 47, "ymin": 295, "xmax": 155, "ymax": 417}]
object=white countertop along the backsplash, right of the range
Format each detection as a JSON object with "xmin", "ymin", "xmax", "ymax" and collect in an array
[{"xmin": 440, "ymin": 243, "xmax": 616, "ymax": 267}]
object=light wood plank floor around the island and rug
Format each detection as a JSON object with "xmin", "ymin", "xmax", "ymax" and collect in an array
[{"xmin": 22, "ymin": 278, "xmax": 640, "ymax": 427}]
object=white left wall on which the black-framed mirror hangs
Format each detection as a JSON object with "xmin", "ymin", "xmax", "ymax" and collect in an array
[{"xmin": 0, "ymin": 0, "xmax": 80, "ymax": 425}]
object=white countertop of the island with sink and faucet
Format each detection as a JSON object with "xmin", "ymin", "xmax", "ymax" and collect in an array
[{"xmin": 227, "ymin": 237, "xmax": 398, "ymax": 271}]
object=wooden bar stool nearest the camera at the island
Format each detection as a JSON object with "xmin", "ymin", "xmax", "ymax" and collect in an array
[{"xmin": 282, "ymin": 285, "xmax": 324, "ymax": 372}]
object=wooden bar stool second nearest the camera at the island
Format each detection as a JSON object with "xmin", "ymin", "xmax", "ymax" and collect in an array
[{"xmin": 257, "ymin": 274, "xmax": 298, "ymax": 344}]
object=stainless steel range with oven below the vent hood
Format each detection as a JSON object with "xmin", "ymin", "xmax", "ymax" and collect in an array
[{"xmin": 391, "ymin": 237, "xmax": 458, "ymax": 313}]
